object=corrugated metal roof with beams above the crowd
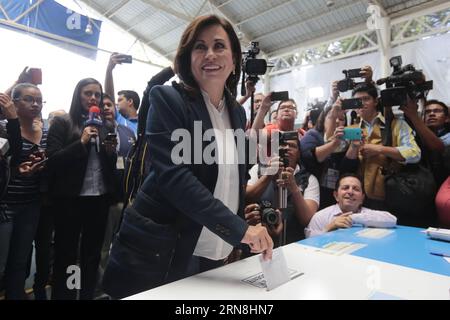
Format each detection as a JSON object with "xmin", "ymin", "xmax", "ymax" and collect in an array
[{"xmin": 79, "ymin": 0, "xmax": 449, "ymax": 66}]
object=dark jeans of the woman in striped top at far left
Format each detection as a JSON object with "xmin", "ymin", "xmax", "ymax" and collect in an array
[{"xmin": 5, "ymin": 201, "xmax": 40, "ymax": 300}]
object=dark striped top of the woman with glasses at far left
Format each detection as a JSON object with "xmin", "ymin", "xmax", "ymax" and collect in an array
[{"xmin": 2, "ymin": 129, "xmax": 48, "ymax": 204}]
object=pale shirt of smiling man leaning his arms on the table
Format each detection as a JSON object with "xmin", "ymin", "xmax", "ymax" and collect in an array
[{"xmin": 305, "ymin": 204, "xmax": 397, "ymax": 238}]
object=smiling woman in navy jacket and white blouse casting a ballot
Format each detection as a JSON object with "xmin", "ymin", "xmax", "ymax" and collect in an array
[{"xmin": 103, "ymin": 15, "xmax": 273, "ymax": 298}]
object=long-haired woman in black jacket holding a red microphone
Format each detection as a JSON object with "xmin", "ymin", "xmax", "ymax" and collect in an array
[{"xmin": 47, "ymin": 78, "xmax": 117, "ymax": 300}]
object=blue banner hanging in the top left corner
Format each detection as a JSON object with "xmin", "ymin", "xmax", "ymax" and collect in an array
[{"xmin": 0, "ymin": 0, "xmax": 102, "ymax": 55}]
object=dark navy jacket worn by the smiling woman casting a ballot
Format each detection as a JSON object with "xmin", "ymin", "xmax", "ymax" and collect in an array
[{"xmin": 103, "ymin": 86, "xmax": 248, "ymax": 297}]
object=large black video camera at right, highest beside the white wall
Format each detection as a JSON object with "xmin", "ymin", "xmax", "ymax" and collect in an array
[{"xmin": 377, "ymin": 56, "xmax": 433, "ymax": 107}]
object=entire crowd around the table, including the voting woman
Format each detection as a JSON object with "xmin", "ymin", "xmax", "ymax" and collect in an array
[{"xmin": 0, "ymin": 15, "xmax": 450, "ymax": 300}]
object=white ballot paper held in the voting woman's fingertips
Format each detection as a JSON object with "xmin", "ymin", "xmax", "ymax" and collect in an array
[{"xmin": 259, "ymin": 248, "xmax": 291, "ymax": 290}]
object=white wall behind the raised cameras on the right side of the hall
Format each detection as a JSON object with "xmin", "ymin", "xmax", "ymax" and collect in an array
[{"xmin": 270, "ymin": 34, "xmax": 450, "ymax": 121}]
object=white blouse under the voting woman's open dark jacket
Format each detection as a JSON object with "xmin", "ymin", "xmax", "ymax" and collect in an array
[{"xmin": 194, "ymin": 92, "xmax": 243, "ymax": 260}]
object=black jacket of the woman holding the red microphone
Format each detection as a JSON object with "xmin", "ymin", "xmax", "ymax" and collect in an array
[{"xmin": 47, "ymin": 115, "xmax": 117, "ymax": 198}]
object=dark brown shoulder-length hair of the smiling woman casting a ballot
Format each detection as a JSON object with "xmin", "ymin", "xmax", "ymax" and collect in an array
[{"xmin": 174, "ymin": 15, "xmax": 242, "ymax": 96}]
